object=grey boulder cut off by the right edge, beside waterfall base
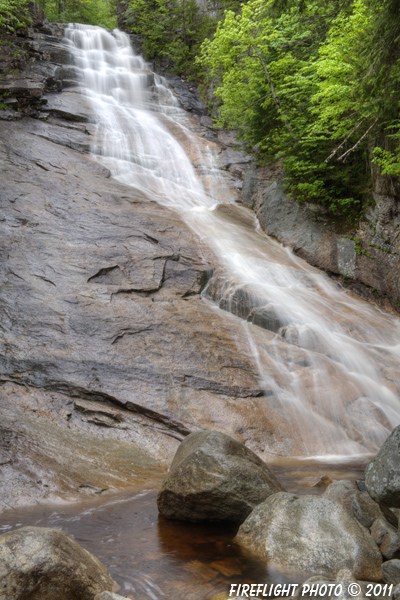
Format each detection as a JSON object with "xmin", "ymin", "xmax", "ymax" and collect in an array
[{"xmin": 365, "ymin": 425, "xmax": 400, "ymax": 508}]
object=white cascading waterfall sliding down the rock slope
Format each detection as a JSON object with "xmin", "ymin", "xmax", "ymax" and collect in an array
[{"xmin": 66, "ymin": 25, "xmax": 400, "ymax": 458}]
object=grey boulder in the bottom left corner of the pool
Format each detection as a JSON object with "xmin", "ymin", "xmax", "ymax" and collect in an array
[{"xmin": 0, "ymin": 527, "xmax": 116, "ymax": 600}]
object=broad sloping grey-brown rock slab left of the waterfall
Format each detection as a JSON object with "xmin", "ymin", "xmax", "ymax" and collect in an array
[{"xmin": 0, "ymin": 44, "xmax": 290, "ymax": 508}]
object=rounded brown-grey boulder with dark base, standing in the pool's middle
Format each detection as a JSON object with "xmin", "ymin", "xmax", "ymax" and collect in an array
[{"xmin": 157, "ymin": 431, "xmax": 284, "ymax": 522}]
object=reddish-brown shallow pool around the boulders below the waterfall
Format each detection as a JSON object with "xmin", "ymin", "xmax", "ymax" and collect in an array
[{"xmin": 0, "ymin": 461, "xmax": 364, "ymax": 600}]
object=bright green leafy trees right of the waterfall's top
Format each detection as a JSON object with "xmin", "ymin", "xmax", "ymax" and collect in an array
[{"xmin": 199, "ymin": 0, "xmax": 400, "ymax": 216}]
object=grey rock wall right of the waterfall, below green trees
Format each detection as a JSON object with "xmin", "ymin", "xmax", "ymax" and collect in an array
[{"xmin": 243, "ymin": 164, "xmax": 400, "ymax": 306}]
